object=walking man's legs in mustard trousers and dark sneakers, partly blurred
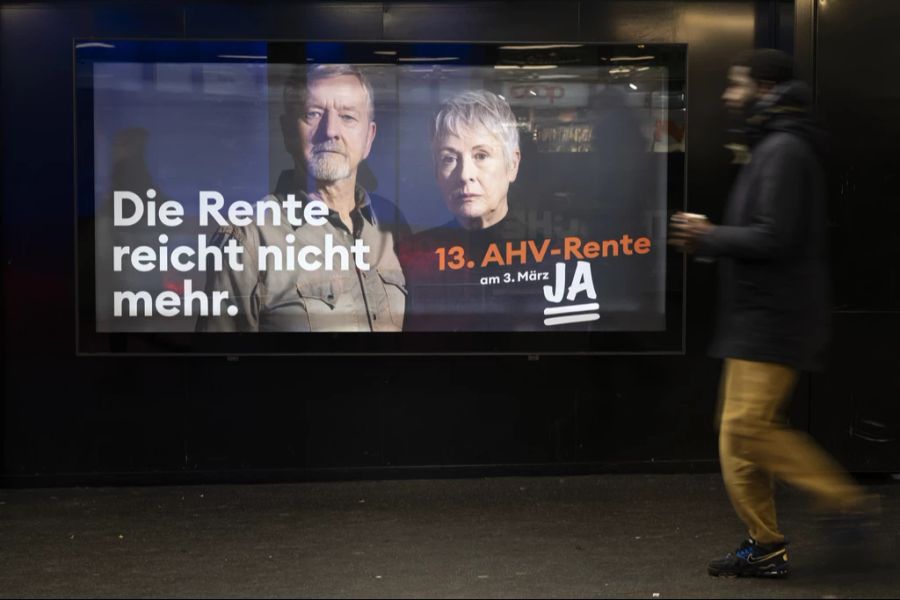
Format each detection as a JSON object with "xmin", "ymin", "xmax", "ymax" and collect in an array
[{"xmin": 709, "ymin": 359, "xmax": 879, "ymax": 577}]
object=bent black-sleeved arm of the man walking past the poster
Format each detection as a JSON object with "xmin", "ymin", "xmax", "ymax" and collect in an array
[{"xmin": 695, "ymin": 143, "xmax": 806, "ymax": 260}]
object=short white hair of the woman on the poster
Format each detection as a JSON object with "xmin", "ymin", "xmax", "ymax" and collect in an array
[{"xmin": 431, "ymin": 90, "xmax": 519, "ymax": 165}]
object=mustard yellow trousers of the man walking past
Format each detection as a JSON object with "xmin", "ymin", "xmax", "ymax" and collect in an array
[{"xmin": 719, "ymin": 358, "xmax": 864, "ymax": 544}]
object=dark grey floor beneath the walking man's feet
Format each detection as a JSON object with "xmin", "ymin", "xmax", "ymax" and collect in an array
[{"xmin": 0, "ymin": 474, "xmax": 900, "ymax": 598}]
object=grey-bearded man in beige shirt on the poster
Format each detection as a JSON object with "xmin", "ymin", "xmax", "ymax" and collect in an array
[{"xmin": 197, "ymin": 64, "xmax": 406, "ymax": 332}]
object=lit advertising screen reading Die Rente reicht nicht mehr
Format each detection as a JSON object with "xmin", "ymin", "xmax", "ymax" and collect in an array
[{"xmin": 75, "ymin": 40, "xmax": 686, "ymax": 352}]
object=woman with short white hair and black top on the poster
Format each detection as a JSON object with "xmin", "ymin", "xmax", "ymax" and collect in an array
[{"xmin": 401, "ymin": 90, "xmax": 544, "ymax": 332}]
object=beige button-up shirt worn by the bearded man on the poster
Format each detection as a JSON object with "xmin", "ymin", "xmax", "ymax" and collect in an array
[{"xmin": 197, "ymin": 187, "xmax": 406, "ymax": 332}]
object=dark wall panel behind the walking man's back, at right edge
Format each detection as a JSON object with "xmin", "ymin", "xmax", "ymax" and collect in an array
[{"xmin": 811, "ymin": 0, "xmax": 900, "ymax": 471}]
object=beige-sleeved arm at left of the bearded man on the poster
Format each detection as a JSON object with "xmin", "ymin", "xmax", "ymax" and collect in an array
[{"xmin": 197, "ymin": 226, "xmax": 260, "ymax": 332}]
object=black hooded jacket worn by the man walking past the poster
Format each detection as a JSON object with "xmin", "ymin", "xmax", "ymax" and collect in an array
[{"xmin": 698, "ymin": 82, "xmax": 830, "ymax": 370}]
